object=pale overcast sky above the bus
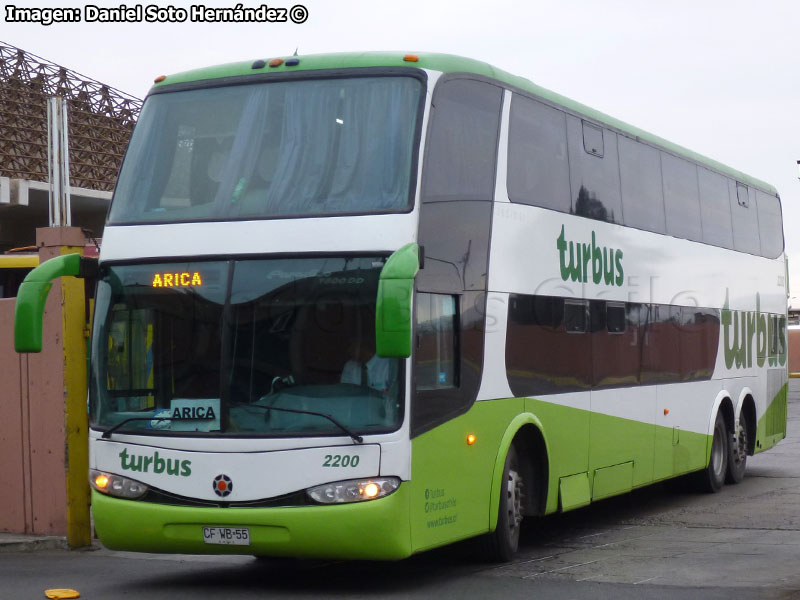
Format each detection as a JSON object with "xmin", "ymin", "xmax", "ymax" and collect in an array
[{"xmin": 6, "ymin": 0, "xmax": 800, "ymax": 295}]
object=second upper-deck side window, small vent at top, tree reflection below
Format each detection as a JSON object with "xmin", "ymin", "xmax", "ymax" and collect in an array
[{"xmin": 567, "ymin": 115, "xmax": 622, "ymax": 223}]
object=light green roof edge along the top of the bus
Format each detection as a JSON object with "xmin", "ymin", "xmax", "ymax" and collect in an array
[{"xmin": 151, "ymin": 52, "xmax": 777, "ymax": 195}]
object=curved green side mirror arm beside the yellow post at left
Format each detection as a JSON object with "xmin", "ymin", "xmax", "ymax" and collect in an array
[{"xmin": 14, "ymin": 254, "xmax": 97, "ymax": 352}]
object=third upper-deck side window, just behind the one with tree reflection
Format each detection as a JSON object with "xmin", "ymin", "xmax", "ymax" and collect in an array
[{"xmin": 619, "ymin": 137, "xmax": 666, "ymax": 233}]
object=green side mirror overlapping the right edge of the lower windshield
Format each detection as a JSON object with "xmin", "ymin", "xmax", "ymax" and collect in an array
[{"xmin": 375, "ymin": 243, "xmax": 419, "ymax": 358}]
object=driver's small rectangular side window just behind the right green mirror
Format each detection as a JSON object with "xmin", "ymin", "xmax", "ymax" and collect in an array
[{"xmin": 415, "ymin": 292, "xmax": 458, "ymax": 391}]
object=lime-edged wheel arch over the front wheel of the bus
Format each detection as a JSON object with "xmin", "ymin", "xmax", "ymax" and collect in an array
[{"xmin": 489, "ymin": 413, "xmax": 550, "ymax": 531}]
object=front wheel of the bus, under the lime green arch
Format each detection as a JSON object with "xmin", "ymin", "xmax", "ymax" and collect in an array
[{"xmin": 486, "ymin": 444, "xmax": 523, "ymax": 562}]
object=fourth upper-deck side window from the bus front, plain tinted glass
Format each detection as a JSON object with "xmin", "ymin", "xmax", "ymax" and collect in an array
[{"xmin": 661, "ymin": 152, "xmax": 703, "ymax": 242}]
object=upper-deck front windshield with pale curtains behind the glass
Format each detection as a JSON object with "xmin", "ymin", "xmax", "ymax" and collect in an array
[{"xmin": 109, "ymin": 76, "xmax": 423, "ymax": 224}]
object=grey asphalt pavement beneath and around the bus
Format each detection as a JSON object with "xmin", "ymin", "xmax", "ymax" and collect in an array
[{"xmin": 0, "ymin": 379, "xmax": 800, "ymax": 600}]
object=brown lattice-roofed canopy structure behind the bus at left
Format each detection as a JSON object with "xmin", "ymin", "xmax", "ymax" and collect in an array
[{"xmin": 0, "ymin": 42, "xmax": 142, "ymax": 251}]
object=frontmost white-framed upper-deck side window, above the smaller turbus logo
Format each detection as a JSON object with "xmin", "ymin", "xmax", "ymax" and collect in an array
[{"xmin": 508, "ymin": 94, "xmax": 570, "ymax": 212}]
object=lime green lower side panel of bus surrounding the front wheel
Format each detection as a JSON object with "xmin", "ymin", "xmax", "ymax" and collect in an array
[{"xmin": 409, "ymin": 398, "xmax": 710, "ymax": 552}]
